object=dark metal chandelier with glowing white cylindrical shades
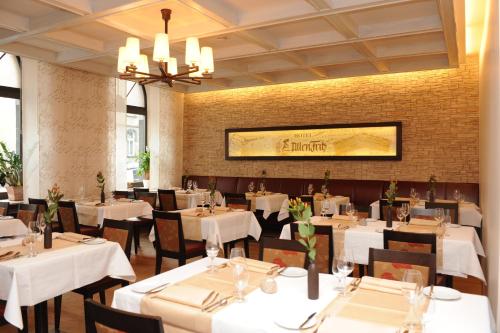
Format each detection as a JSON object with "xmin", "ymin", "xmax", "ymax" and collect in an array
[{"xmin": 117, "ymin": 9, "xmax": 214, "ymax": 87}]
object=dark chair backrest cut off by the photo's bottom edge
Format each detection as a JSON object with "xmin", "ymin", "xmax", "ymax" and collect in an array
[{"xmin": 84, "ymin": 299, "xmax": 163, "ymax": 333}]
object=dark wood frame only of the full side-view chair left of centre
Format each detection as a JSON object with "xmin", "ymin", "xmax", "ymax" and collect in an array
[{"xmin": 153, "ymin": 210, "xmax": 206, "ymax": 274}]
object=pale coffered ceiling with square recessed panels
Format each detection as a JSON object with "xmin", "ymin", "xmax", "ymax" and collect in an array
[{"xmin": 0, "ymin": 0, "xmax": 464, "ymax": 92}]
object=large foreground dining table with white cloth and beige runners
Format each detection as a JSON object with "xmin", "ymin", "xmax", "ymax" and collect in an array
[{"xmin": 112, "ymin": 258, "xmax": 495, "ymax": 333}]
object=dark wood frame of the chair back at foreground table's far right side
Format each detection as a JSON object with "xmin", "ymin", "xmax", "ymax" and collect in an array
[{"xmin": 368, "ymin": 248, "xmax": 436, "ymax": 285}]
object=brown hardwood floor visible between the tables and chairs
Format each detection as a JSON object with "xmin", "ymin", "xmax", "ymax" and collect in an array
[{"xmin": 0, "ymin": 231, "xmax": 485, "ymax": 333}]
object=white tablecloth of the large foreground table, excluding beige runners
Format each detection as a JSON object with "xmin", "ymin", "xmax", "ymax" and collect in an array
[{"xmin": 112, "ymin": 258, "xmax": 494, "ymax": 333}]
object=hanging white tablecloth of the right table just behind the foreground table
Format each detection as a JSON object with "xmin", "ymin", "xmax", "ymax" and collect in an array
[{"xmin": 280, "ymin": 217, "xmax": 486, "ymax": 282}]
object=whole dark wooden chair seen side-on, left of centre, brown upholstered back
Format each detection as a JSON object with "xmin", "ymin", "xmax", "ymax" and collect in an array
[{"xmin": 153, "ymin": 210, "xmax": 206, "ymax": 274}]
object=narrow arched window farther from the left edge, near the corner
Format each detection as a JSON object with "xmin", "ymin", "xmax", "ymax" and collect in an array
[{"xmin": 126, "ymin": 81, "xmax": 147, "ymax": 183}]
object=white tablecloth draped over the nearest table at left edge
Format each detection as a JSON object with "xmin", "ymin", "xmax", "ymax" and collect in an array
[{"xmin": 0, "ymin": 233, "xmax": 135, "ymax": 329}]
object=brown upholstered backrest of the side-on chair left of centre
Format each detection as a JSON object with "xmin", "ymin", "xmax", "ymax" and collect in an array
[{"xmin": 153, "ymin": 210, "xmax": 186, "ymax": 254}]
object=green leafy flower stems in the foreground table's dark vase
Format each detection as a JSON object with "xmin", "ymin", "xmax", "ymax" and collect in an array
[{"xmin": 288, "ymin": 198, "xmax": 316, "ymax": 261}]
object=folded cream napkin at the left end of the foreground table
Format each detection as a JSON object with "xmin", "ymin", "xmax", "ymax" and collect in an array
[{"xmin": 154, "ymin": 284, "xmax": 219, "ymax": 309}]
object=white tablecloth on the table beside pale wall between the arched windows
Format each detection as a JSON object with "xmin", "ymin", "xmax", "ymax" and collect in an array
[{"xmin": 76, "ymin": 201, "xmax": 153, "ymax": 226}]
